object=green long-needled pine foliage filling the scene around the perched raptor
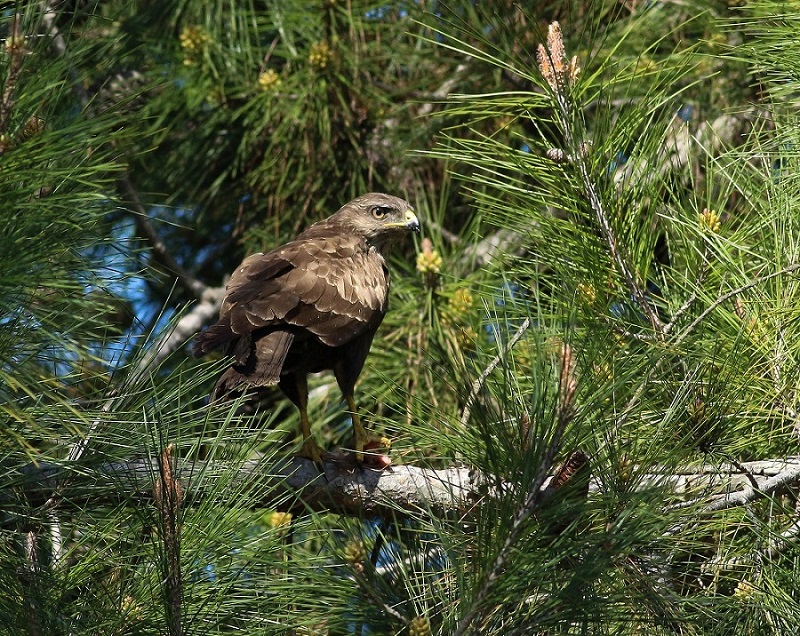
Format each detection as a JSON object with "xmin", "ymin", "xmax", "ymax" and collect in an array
[{"xmin": 0, "ymin": 0, "xmax": 800, "ymax": 636}]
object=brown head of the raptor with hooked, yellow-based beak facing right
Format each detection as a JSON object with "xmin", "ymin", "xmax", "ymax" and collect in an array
[{"xmin": 331, "ymin": 192, "xmax": 419, "ymax": 248}]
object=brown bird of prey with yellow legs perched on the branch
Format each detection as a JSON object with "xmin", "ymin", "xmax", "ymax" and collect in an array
[{"xmin": 194, "ymin": 193, "xmax": 419, "ymax": 463}]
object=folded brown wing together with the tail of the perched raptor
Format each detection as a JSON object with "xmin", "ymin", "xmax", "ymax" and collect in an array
[{"xmin": 195, "ymin": 224, "xmax": 388, "ymax": 378}]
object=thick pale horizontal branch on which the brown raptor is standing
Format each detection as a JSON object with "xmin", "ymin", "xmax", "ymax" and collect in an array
[{"xmin": 14, "ymin": 457, "xmax": 800, "ymax": 518}]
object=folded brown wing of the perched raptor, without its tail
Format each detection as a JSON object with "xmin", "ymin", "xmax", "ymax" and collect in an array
[{"xmin": 223, "ymin": 234, "xmax": 388, "ymax": 346}]
